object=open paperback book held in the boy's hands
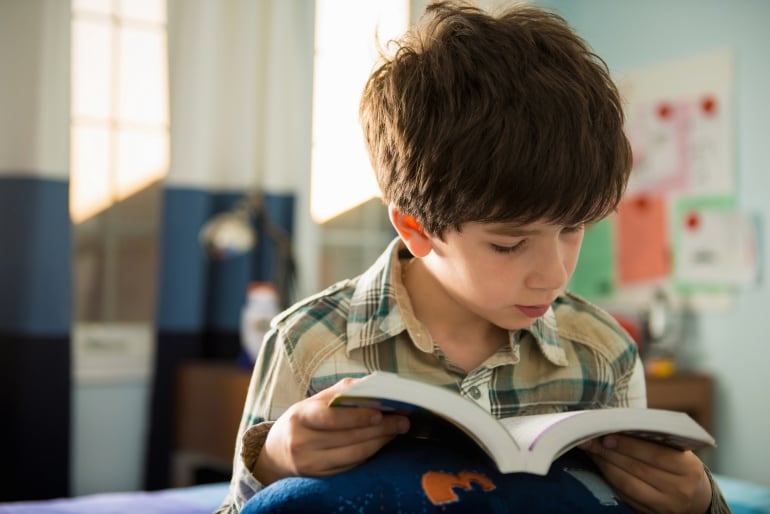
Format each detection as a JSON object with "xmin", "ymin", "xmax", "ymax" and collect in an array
[{"xmin": 331, "ymin": 372, "xmax": 716, "ymax": 475}]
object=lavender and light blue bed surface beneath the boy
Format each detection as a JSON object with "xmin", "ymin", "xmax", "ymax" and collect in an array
[{"xmin": 0, "ymin": 475, "xmax": 770, "ymax": 514}]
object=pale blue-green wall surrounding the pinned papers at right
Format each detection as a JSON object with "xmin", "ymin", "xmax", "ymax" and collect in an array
[{"xmin": 539, "ymin": 0, "xmax": 770, "ymax": 485}]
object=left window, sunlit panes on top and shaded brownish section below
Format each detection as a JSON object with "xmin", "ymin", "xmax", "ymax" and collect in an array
[{"xmin": 70, "ymin": 0, "xmax": 169, "ymax": 321}]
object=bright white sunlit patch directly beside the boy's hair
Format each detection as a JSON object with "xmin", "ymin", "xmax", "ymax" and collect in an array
[{"xmin": 310, "ymin": 0, "xmax": 409, "ymax": 223}]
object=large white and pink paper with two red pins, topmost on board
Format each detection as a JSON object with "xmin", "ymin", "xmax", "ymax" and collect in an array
[{"xmin": 619, "ymin": 51, "xmax": 735, "ymax": 196}]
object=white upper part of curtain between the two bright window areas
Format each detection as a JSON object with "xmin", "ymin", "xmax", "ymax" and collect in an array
[{"xmin": 167, "ymin": 0, "xmax": 315, "ymax": 192}]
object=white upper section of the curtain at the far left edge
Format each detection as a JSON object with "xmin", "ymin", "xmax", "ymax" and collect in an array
[{"xmin": 0, "ymin": 1, "xmax": 70, "ymax": 179}]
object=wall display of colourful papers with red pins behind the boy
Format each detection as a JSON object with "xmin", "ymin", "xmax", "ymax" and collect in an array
[{"xmin": 570, "ymin": 51, "xmax": 760, "ymax": 310}]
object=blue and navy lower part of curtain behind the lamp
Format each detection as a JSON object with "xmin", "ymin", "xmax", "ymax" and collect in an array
[{"xmin": 144, "ymin": 187, "xmax": 295, "ymax": 489}]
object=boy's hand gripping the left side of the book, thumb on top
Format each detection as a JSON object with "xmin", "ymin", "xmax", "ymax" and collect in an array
[{"xmin": 254, "ymin": 378, "xmax": 409, "ymax": 485}]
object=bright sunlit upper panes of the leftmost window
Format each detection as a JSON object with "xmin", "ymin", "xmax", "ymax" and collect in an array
[{"xmin": 70, "ymin": 0, "xmax": 169, "ymax": 223}]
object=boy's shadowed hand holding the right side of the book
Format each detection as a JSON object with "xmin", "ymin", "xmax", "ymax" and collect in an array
[{"xmin": 581, "ymin": 435, "xmax": 711, "ymax": 514}]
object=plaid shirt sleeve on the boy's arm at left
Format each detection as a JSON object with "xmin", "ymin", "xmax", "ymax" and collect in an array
[{"xmin": 216, "ymin": 328, "xmax": 307, "ymax": 514}]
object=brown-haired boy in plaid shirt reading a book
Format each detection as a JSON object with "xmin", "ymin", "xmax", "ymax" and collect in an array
[{"xmin": 216, "ymin": 3, "xmax": 729, "ymax": 513}]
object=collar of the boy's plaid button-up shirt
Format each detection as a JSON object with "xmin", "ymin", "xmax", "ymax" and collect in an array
[{"xmin": 347, "ymin": 237, "xmax": 567, "ymax": 366}]
